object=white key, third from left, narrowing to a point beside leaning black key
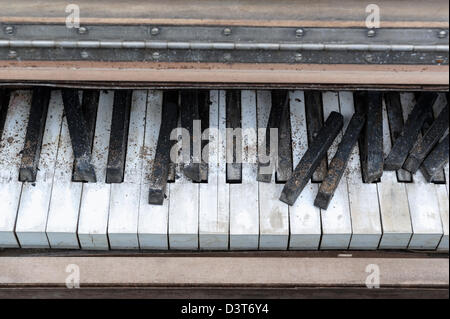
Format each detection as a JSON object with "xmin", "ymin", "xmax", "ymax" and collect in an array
[{"xmin": 47, "ymin": 113, "xmax": 83, "ymax": 249}]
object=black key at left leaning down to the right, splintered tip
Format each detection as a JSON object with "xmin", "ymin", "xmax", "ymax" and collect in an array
[{"xmin": 62, "ymin": 89, "xmax": 97, "ymax": 183}]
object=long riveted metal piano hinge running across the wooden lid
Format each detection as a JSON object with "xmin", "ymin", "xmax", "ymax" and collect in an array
[{"xmin": 0, "ymin": 24, "xmax": 449, "ymax": 65}]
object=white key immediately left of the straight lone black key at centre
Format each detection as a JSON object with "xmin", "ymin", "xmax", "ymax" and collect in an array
[{"xmin": 199, "ymin": 91, "xmax": 230, "ymax": 250}]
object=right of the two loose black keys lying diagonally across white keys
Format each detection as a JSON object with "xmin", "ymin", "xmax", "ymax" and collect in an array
[{"xmin": 314, "ymin": 113, "xmax": 366, "ymax": 209}]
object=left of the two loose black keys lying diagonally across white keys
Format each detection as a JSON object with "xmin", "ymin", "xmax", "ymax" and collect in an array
[{"xmin": 280, "ymin": 112, "xmax": 343, "ymax": 206}]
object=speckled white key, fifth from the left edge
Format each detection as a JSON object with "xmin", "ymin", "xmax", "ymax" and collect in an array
[{"xmin": 108, "ymin": 90, "xmax": 147, "ymax": 249}]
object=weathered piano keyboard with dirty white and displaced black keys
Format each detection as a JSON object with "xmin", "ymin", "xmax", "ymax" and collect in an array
[{"xmin": 0, "ymin": 89, "xmax": 449, "ymax": 251}]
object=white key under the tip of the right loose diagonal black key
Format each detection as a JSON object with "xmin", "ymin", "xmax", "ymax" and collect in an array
[{"xmin": 320, "ymin": 92, "xmax": 352, "ymax": 249}]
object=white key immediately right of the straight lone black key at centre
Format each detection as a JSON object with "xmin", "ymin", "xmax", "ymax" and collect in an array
[{"xmin": 230, "ymin": 91, "xmax": 259, "ymax": 250}]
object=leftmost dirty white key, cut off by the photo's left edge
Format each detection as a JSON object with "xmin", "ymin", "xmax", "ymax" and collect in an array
[{"xmin": 0, "ymin": 91, "xmax": 32, "ymax": 248}]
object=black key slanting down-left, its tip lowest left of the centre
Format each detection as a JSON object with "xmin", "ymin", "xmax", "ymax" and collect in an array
[{"xmin": 148, "ymin": 91, "xmax": 178, "ymax": 205}]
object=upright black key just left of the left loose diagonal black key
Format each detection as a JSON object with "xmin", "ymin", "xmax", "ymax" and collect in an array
[{"xmin": 272, "ymin": 91, "xmax": 294, "ymax": 183}]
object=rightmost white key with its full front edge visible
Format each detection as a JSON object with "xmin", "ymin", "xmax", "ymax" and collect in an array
[{"xmin": 400, "ymin": 93, "xmax": 443, "ymax": 249}]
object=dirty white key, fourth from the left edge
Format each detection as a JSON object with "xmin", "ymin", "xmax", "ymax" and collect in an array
[{"xmin": 78, "ymin": 91, "xmax": 114, "ymax": 250}]
